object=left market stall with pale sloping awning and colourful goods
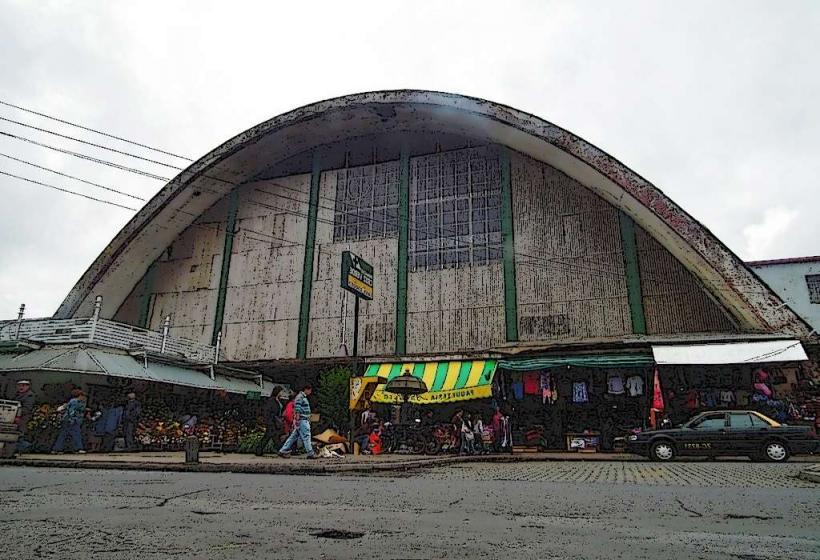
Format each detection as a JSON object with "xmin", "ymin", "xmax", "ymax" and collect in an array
[{"xmin": 0, "ymin": 345, "xmax": 273, "ymax": 451}]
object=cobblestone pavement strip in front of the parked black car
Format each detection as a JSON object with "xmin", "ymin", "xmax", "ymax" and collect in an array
[{"xmin": 427, "ymin": 462, "xmax": 818, "ymax": 489}]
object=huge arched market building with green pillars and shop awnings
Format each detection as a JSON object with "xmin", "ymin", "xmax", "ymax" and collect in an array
[{"xmin": 0, "ymin": 90, "xmax": 816, "ymax": 448}]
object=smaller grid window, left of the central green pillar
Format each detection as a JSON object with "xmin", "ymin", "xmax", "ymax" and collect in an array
[{"xmin": 333, "ymin": 162, "xmax": 399, "ymax": 242}]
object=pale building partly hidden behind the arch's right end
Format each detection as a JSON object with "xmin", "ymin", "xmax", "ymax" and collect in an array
[{"xmin": 747, "ymin": 256, "xmax": 820, "ymax": 332}]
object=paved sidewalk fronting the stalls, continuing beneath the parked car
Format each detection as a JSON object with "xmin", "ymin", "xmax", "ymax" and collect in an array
[{"xmin": 0, "ymin": 452, "xmax": 820, "ymax": 474}]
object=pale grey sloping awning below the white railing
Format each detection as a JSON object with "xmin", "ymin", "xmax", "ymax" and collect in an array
[{"xmin": 0, "ymin": 346, "xmax": 273, "ymax": 396}]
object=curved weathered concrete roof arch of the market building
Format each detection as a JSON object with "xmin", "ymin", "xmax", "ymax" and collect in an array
[{"xmin": 55, "ymin": 90, "xmax": 809, "ymax": 335}]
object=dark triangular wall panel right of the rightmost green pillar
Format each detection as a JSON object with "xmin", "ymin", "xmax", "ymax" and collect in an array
[{"xmin": 635, "ymin": 227, "xmax": 737, "ymax": 334}]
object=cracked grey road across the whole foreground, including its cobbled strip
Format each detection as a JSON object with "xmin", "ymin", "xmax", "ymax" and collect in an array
[{"xmin": 0, "ymin": 462, "xmax": 820, "ymax": 560}]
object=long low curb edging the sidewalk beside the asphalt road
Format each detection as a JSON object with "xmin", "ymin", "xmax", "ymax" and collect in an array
[{"xmin": 0, "ymin": 454, "xmax": 645, "ymax": 475}]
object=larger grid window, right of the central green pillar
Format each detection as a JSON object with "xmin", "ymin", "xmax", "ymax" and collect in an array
[{"xmin": 409, "ymin": 148, "xmax": 502, "ymax": 270}]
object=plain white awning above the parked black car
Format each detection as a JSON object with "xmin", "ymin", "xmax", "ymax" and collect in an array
[{"xmin": 652, "ymin": 340, "xmax": 808, "ymax": 365}]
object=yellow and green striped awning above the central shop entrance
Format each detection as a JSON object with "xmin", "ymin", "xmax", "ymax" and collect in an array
[{"xmin": 364, "ymin": 360, "xmax": 498, "ymax": 404}]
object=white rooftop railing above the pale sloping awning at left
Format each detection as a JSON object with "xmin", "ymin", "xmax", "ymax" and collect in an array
[{"xmin": 0, "ymin": 310, "xmax": 216, "ymax": 363}]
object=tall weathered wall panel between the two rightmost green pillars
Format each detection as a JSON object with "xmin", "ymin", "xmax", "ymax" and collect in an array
[{"xmin": 511, "ymin": 154, "xmax": 632, "ymax": 340}]
